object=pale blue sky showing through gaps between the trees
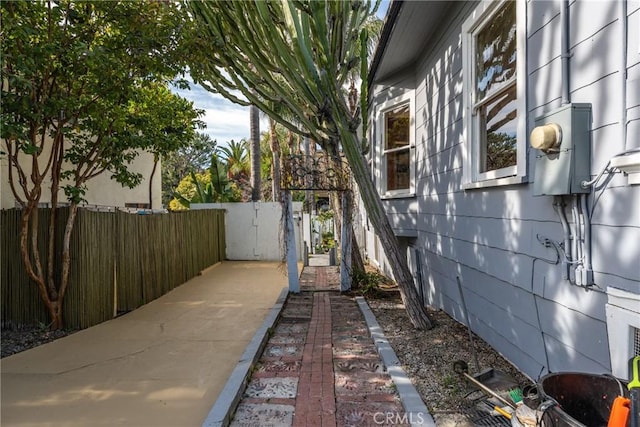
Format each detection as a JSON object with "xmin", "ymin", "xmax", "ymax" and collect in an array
[{"xmin": 173, "ymin": 0, "xmax": 389, "ymax": 145}]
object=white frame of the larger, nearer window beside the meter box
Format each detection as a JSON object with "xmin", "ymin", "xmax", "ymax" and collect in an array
[{"xmin": 462, "ymin": 0, "xmax": 528, "ymax": 189}]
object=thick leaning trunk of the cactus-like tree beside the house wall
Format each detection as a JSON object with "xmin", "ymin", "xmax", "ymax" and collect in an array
[{"xmin": 340, "ymin": 128, "xmax": 433, "ymax": 329}]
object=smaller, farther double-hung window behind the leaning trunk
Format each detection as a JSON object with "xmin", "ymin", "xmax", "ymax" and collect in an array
[{"xmin": 377, "ymin": 93, "xmax": 415, "ymax": 197}]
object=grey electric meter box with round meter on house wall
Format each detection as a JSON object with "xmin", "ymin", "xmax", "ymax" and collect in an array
[{"xmin": 530, "ymin": 104, "xmax": 591, "ymax": 196}]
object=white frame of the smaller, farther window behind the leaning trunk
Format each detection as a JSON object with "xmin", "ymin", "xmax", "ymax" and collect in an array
[{"xmin": 375, "ymin": 90, "xmax": 416, "ymax": 199}]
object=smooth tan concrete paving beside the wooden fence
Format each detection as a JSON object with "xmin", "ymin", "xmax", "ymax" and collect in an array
[{"xmin": 0, "ymin": 262, "xmax": 287, "ymax": 426}]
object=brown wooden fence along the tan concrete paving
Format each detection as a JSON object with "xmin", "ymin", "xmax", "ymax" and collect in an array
[{"xmin": 0, "ymin": 209, "xmax": 225, "ymax": 328}]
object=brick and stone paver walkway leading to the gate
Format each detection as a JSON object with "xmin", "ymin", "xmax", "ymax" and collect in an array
[{"xmin": 231, "ymin": 267, "xmax": 406, "ymax": 427}]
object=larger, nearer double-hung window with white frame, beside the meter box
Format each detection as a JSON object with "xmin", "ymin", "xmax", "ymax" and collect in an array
[{"xmin": 462, "ymin": 0, "xmax": 527, "ymax": 188}]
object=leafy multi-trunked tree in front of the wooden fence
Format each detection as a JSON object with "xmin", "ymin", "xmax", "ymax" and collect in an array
[{"xmin": 0, "ymin": 0, "xmax": 202, "ymax": 328}]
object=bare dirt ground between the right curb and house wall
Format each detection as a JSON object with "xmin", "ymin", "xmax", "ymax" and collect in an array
[{"xmin": 367, "ymin": 291, "xmax": 531, "ymax": 426}]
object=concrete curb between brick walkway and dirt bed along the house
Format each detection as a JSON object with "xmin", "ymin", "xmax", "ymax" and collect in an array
[{"xmin": 356, "ymin": 297, "xmax": 436, "ymax": 427}]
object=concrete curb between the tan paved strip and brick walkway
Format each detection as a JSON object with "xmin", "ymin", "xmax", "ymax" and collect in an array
[{"xmin": 202, "ymin": 287, "xmax": 289, "ymax": 427}]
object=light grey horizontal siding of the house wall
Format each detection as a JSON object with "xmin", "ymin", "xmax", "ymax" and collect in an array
[{"xmin": 376, "ymin": 0, "xmax": 640, "ymax": 378}]
